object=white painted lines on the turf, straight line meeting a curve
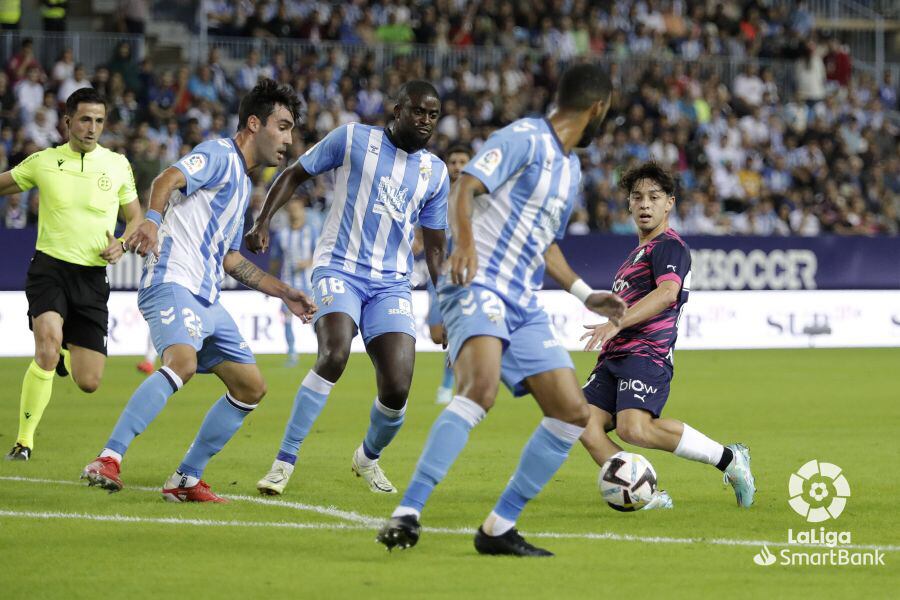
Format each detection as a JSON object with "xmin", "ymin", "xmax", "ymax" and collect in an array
[{"xmin": 0, "ymin": 476, "xmax": 900, "ymax": 552}]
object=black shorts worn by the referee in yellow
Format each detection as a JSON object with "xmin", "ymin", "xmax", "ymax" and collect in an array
[{"xmin": 25, "ymin": 250, "xmax": 109, "ymax": 354}]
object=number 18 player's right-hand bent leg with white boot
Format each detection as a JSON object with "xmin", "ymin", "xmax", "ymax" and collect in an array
[{"xmin": 351, "ymin": 333, "xmax": 416, "ymax": 494}]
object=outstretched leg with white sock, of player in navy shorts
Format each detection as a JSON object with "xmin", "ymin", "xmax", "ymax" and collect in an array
[{"xmin": 616, "ymin": 408, "xmax": 756, "ymax": 508}]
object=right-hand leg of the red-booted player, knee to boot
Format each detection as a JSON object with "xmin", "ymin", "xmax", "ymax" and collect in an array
[{"xmin": 162, "ymin": 361, "xmax": 266, "ymax": 502}]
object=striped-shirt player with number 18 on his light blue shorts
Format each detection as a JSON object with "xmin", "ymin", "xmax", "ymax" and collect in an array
[{"xmin": 247, "ymin": 81, "xmax": 449, "ymax": 494}]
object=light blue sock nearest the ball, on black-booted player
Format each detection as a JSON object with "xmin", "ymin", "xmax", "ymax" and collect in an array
[{"xmin": 494, "ymin": 417, "xmax": 584, "ymax": 523}]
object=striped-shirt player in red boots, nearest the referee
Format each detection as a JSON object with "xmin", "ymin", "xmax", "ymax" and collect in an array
[{"xmin": 82, "ymin": 79, "xmax": 315, "ymax": 502}]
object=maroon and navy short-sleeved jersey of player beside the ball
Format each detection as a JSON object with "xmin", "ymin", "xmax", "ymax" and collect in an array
[{"xmin": 598, "ymin": 229, "xmax": 691, "ymax": 369}]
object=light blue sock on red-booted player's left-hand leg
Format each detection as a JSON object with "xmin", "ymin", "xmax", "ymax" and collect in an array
[{"xmin": 106, "ymin": 367, "xmax": 182, "ymax": 456}]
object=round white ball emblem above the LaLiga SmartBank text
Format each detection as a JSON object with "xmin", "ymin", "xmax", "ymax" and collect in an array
[{"xmin": 788, "ymin": 460, "xmax": 850, "ymax": 523}]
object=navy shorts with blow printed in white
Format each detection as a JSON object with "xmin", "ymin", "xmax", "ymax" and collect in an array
[{"xmin": 584, "ymin": 356, "xmax": 672, "ymax": 417}]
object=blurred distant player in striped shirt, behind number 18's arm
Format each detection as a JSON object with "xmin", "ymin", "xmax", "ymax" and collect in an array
[{"xmin": 269, "ymin": 196, "xmax": 319, "ymax": 367}]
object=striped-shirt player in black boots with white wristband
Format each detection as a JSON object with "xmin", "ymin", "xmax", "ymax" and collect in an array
[{"xmin": 378, "ymin": 64, "xmax": 625, "ymax": 556}]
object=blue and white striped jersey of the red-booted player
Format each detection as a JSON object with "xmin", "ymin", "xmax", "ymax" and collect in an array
[{"xmin": 141, "ymin": 139, "xmax": 252, "ymax": 302}]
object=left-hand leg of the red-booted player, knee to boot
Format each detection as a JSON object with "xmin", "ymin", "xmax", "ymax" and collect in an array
[{"xmin": 81, "ymin": 364, "xmax": 185, "ymax": 492}]
